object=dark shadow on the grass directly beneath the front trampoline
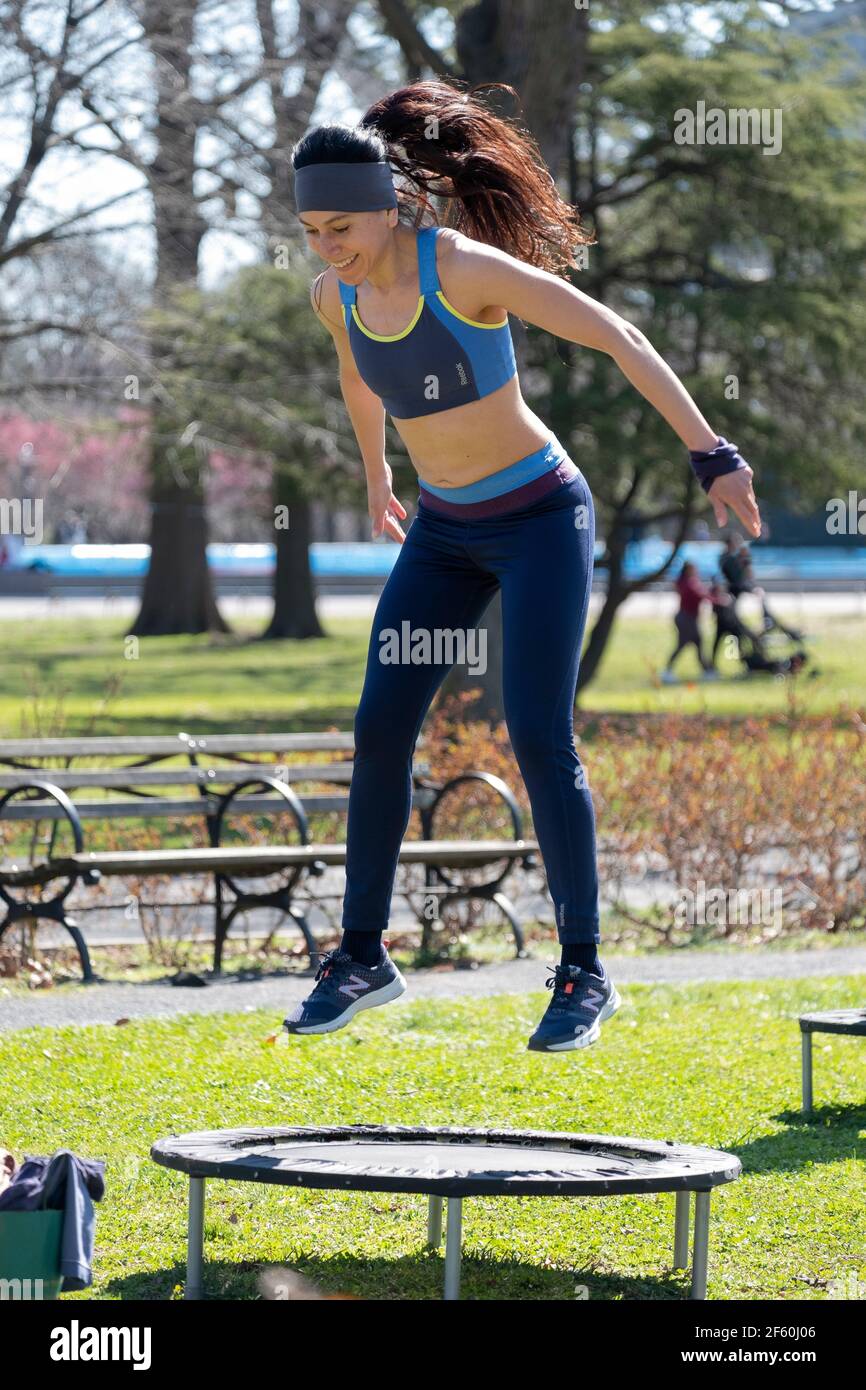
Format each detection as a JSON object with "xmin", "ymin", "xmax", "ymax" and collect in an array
[{"xmin": 99, "ymin": 1250, "xmax": 697, "ymax": 1302}]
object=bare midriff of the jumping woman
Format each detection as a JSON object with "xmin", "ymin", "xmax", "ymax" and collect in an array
[{"xmin": 393, "ymin": 375, "xmax": 552, "ymax": 488}]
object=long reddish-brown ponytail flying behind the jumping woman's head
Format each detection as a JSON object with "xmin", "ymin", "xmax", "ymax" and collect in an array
[{"xmin": 359, "ymin": 79, "xmax": 595, "ymax": 274}]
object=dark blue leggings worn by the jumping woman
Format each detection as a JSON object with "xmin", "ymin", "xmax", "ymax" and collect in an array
[{"xmin": 342, "ymin": 473, "xmax": 601, "ymax": 944}]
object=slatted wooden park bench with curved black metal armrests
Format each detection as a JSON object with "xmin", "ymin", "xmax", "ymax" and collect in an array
[{"xmin": 0, "ymin": 733, "xmax": 538, "ymax": 981}]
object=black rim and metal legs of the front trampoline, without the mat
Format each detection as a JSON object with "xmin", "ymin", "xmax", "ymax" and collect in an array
[{"xmin": 150, "ymin": 1125, "xmax": 742, "ymax": 1301}]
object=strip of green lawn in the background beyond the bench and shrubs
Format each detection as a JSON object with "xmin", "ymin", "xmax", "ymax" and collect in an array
[{"xmin": 0, "ymin": 616, "xmax": 866, "ymax": 738}]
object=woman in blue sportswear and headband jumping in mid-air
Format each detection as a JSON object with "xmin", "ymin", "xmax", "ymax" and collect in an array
[{"xmin": 285, "ymin": 81, "xmax": 760, "ymax": 1052}]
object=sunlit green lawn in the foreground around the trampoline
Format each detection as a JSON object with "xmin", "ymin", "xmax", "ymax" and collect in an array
[{"xmin": 0, "ymin": 976, "xmax": 866, "ymax": 1300}]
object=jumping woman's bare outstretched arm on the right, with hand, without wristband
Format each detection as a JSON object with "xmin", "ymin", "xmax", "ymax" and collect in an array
[{"xmin": 445, "ymin": 238, "xmax": 760, "ymax": 534}]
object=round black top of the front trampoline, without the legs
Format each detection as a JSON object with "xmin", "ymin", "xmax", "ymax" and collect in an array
[{"xmin": 150, "ymin": 1125, "xmax": 742, "ymax": 1197}]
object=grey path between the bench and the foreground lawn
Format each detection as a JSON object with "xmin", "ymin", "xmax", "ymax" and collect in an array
[{"xmin": 0, "ymin": 945, "xmax": 866, "ymax": 1031}]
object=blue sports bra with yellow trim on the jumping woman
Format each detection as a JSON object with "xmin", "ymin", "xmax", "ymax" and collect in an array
[{"xmin": 338, "ymin": 227, "xmax": 517, "ymax": 420}]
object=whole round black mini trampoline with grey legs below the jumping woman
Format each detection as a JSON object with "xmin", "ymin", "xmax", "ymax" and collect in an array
[{"xmin": 150, "ymin": 1125, "xmax": 742, "ymax": 1300}]
